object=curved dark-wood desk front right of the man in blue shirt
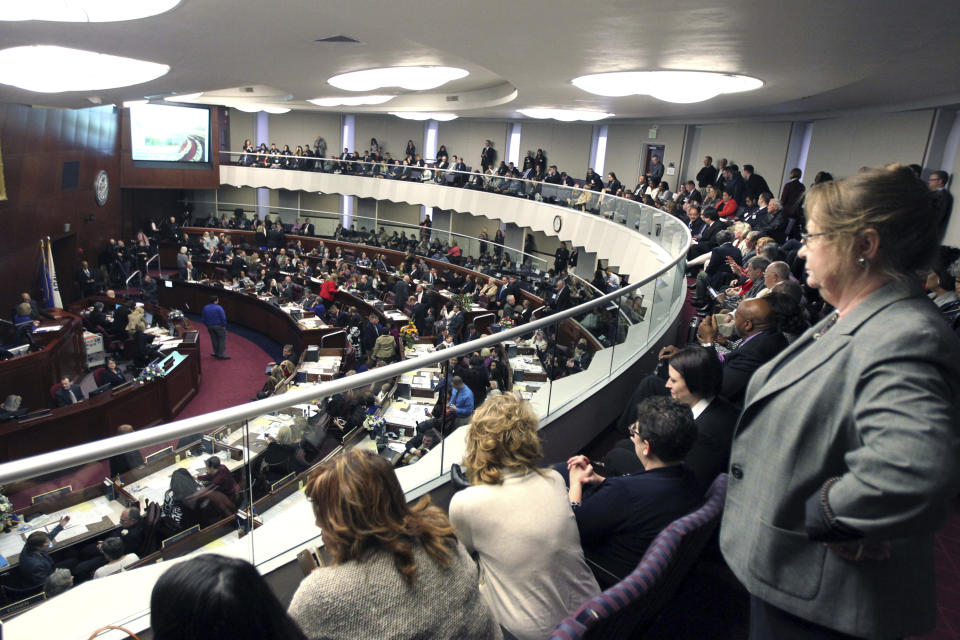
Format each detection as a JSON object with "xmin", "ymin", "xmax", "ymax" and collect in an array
[{"xmin": 158, "ymin": 278, "xmax": 346, "ymax": 352}]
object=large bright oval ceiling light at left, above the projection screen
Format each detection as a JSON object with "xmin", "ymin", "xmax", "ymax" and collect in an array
[{"xmin": 0, "ymin": 45, "xmax": 170, "ymax": 93}]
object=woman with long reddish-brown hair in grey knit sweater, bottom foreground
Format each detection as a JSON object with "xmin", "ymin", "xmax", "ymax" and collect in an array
[{"xmin": 290, "ymin": 448, "xmax": 501, "ymax": 640}]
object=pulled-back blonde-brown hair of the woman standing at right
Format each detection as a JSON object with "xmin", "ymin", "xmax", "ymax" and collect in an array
[{"xmin": 805, "ymin": 164, "xmax": 941, "ymax": 280}]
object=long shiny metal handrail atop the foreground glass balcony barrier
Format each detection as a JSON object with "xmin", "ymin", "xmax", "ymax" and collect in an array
[{"xmin": 0, "ymin": 245, "xmax": 686, "ymax": 485}]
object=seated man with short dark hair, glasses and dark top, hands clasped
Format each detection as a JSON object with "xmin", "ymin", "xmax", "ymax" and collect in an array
[{"xmin": 565, "ymin": 397, "xmax": 703, "ymax": 588}]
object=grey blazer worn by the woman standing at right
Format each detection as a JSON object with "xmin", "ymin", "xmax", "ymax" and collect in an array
[{"xmin": 720, "ymin": 282, "xmax": 960, "ymax": 638}]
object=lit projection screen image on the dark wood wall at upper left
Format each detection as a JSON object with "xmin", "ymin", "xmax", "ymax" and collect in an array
[{"xmin": 130, "ymin": 104, "xmax": 210, "ymax": 162}]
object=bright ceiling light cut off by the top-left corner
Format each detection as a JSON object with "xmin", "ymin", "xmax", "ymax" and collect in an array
[{"xmin": 0, "ymin": 0, "xmax": 180, "ymax": 22}]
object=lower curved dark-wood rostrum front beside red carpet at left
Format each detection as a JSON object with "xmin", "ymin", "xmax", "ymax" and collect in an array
[{"xmin": 0, "ymin": 331, "xmax": 200, "ymax": 462}]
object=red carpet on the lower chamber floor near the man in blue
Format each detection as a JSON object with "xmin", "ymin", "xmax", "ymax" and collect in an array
[{"xmin": 8, "ymin": 322, "xmax": 273, "ymax": 509}]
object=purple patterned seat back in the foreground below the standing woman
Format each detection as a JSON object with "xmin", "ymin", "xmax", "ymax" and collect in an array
[{"xmin": 549, "ymin": 473, "xmax": 727, "ymax": 640}]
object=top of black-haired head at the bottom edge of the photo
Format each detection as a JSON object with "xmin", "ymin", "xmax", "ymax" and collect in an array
[{"xmin": 150, "ymin": 554, "xmax": 306, "ymax": 640}]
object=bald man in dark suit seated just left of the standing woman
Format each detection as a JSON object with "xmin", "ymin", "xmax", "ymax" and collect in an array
[{"xmin": 697, "ymin": 298, "xmax": 787, "ymax": 405}]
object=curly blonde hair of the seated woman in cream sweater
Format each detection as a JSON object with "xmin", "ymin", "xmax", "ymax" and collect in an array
[{"xmin": 463, "ymin": 393, "xmax": 543, "ymax": 484}]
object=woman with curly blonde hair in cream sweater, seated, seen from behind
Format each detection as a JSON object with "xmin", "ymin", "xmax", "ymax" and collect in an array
[{"xmin": 450, "ymin": 394, "xmax": 600, "ymax": 640}]
